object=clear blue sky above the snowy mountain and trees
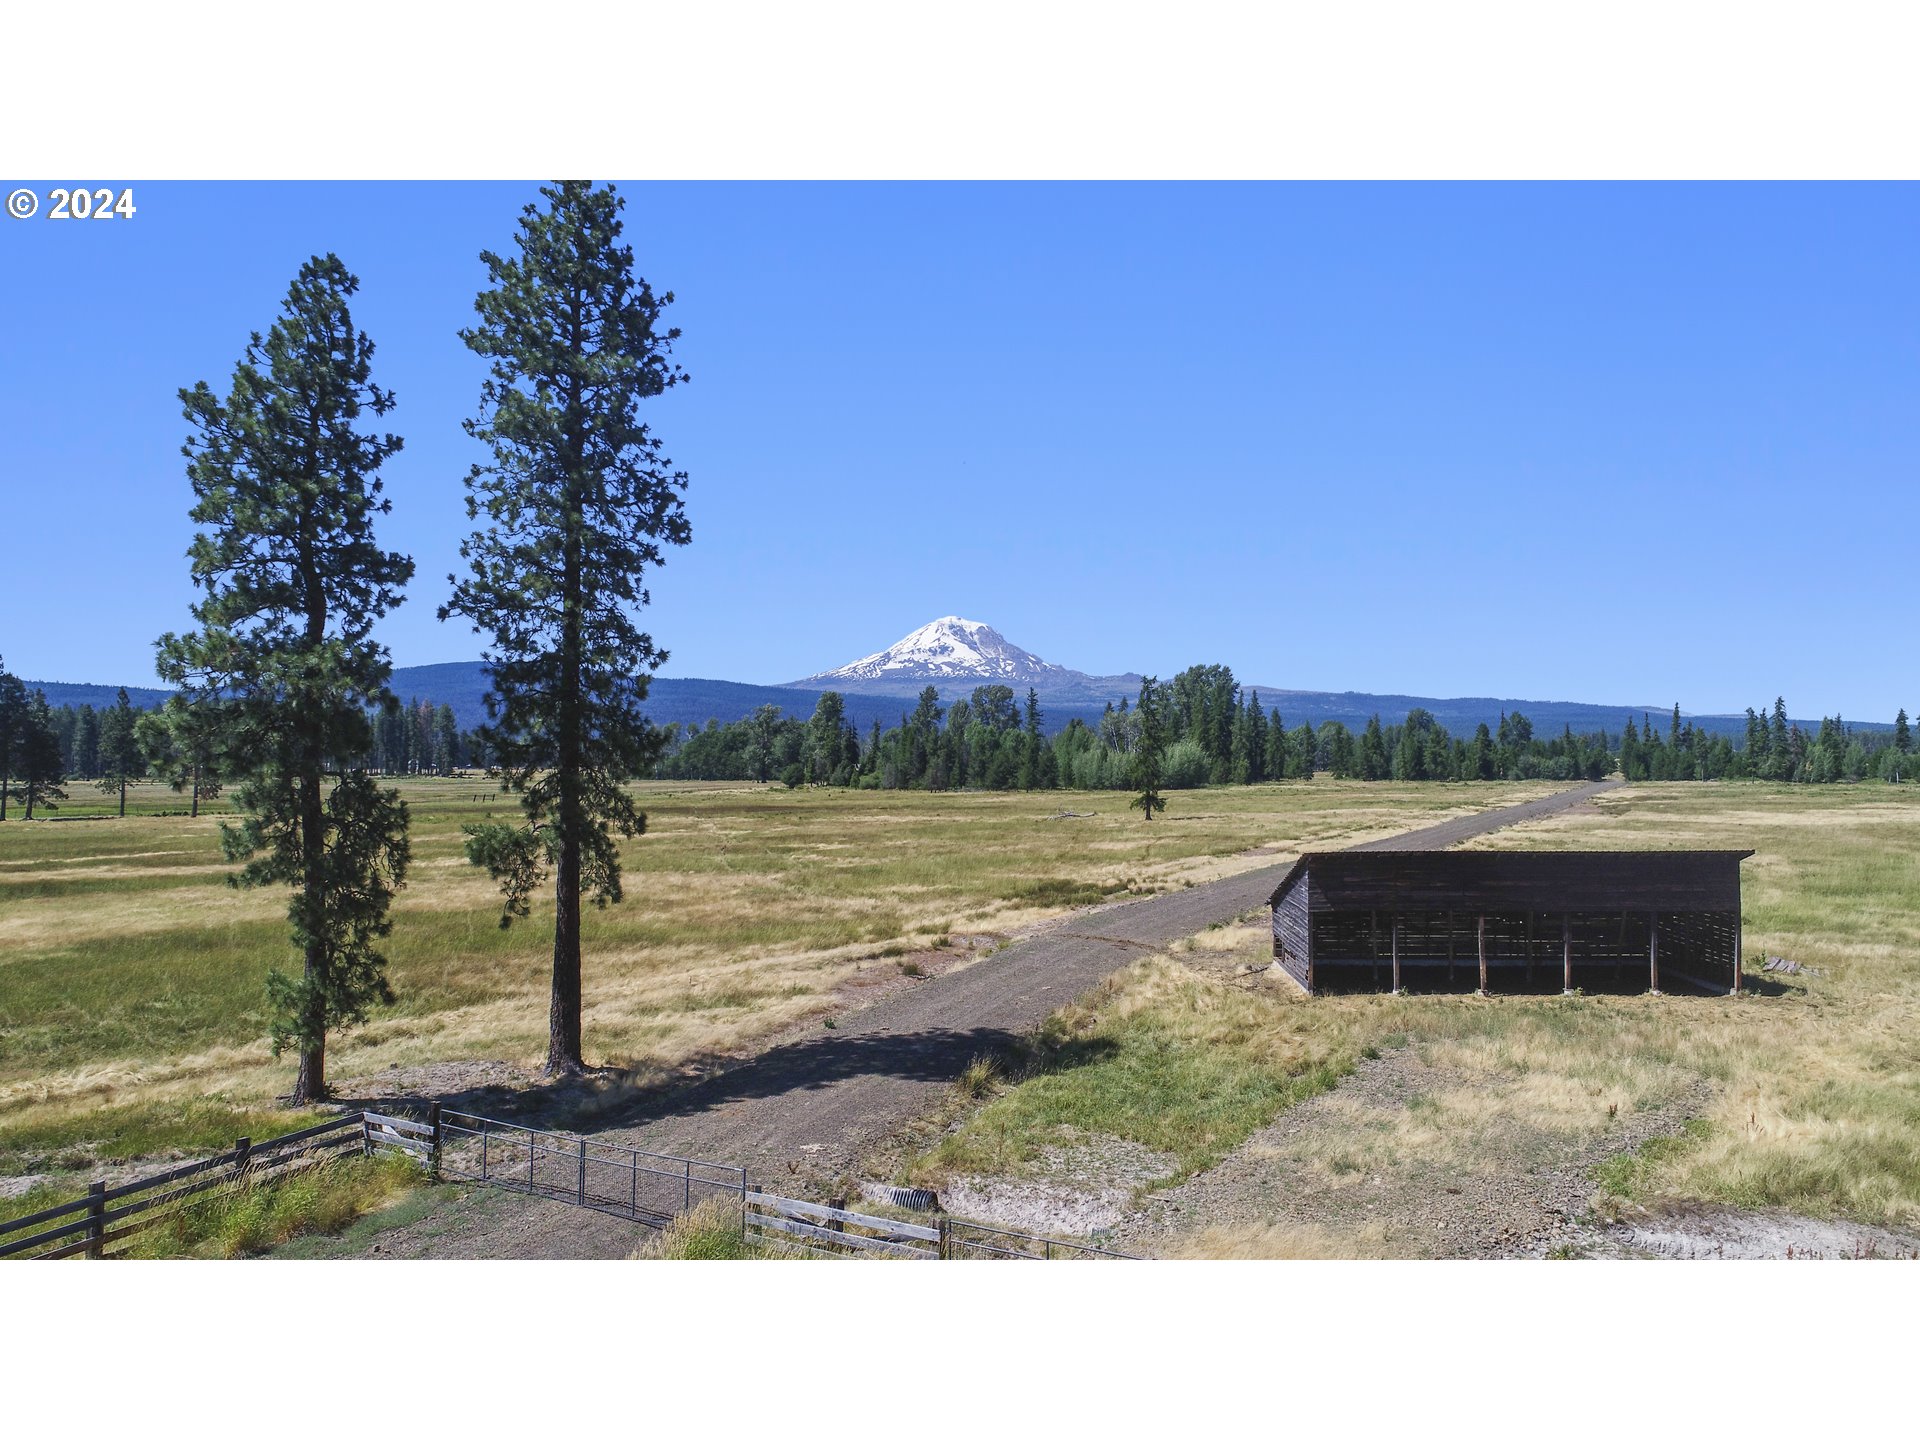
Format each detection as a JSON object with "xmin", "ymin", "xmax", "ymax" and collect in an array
[{"xmin": 0, "ymin": 182, "xmax": 1920, "ymax": 720}]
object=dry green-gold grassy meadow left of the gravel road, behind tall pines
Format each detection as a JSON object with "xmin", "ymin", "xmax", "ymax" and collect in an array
[{"xmin": 0, "ymin": 780, "xmax": 1551, "ymax": 1175}]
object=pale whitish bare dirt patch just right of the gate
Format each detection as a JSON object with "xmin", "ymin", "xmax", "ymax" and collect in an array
[{"xmin": 941, "ymin": 1135, "xmax": 1175, "ymax": 1235}]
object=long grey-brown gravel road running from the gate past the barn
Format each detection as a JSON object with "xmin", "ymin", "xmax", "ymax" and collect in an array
[{"xmin": 366, "ymin": 781, "xmax": 1613, "ymax": 1258}]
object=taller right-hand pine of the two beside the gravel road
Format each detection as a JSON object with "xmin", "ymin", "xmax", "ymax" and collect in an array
[{"xmin": 440, "ymin": 180, "xmax": 689, "ymax": 1073}]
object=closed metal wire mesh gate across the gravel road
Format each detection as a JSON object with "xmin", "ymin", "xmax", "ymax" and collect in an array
[{"xmin": 440, "ymin": 1110, "xmax": 747, "ymax": 1227}]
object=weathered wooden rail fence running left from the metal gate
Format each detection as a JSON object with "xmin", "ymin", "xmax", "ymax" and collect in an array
[{"xmin": 0, "ymin": 1106, "xmax": 438, "ymax": 1260}]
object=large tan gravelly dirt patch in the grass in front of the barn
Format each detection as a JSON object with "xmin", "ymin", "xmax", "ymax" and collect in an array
[{"xmin": 1117, "ymin": 1046, "xmax": 1709, "ymax": 1258}]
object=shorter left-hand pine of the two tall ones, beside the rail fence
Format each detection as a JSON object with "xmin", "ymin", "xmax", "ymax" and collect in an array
[{"xmin": 157, "ymin": 255, "xmax": 413, "ymax": 1104}]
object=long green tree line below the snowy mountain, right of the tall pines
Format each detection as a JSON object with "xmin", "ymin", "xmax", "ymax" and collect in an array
[{"xmin": 655, "ymin": 664, "xmax": 1914, "ymax": 791}]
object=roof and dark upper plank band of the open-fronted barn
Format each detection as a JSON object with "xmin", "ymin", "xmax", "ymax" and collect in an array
[{"xmin": 1269, "ymin": 851, "xmax": 1753, "ymax": 912}]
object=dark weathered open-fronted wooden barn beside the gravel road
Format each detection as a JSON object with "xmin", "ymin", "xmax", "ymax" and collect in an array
[{"xmin": 1271, "ymin": 851, "xmax": 1753, "ymax": 995}]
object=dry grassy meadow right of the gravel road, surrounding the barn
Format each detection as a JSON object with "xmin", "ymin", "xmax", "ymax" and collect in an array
[{"xmin": 904, "ymin": 783, "xmax": 1920, "ymax": 1256}]
